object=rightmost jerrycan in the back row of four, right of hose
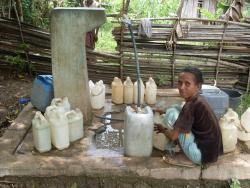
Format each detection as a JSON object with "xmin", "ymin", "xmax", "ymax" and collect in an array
[{"xmin": 145, "ymin": 77, "xmax": 157, "ymax": 105}]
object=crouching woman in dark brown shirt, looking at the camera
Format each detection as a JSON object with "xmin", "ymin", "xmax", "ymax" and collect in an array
[{"xmin": 155, "ymin": 67, "xmax": 223, "ymax": 165}]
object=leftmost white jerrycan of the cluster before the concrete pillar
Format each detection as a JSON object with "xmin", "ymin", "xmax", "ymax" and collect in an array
[{"xmin": 32, "ymin": 111, "xmax": 51, "ymax": 153}]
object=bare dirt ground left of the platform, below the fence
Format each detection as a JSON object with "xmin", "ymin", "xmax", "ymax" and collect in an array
[{"xmin": 0, "ymin": 72, "xmax": 33, "ymax": 137}]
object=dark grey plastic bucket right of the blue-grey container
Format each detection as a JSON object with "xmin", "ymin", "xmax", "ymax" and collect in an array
[{"xmin": 221, "ymin": 88, "xmax": 241, "ymax": 110}]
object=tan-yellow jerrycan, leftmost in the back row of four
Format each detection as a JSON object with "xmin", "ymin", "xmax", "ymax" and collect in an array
[{"xmin": 111, "ymin": 77, "xmax": 123, "ymax": 104}]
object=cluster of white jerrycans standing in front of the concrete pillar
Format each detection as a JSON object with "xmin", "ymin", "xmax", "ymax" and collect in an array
[{"xmin": 32, "ymin": 97, "xmax": 83, "ymax": 152}]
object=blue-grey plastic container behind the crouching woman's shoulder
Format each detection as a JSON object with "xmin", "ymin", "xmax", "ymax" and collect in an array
[{"xmin": 201, "ymin": 90, "xmax": 229, "ymax": 119}]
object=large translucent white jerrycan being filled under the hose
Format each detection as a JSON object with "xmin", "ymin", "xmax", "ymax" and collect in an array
[{"xmin": 124, "ymin": 106, "xmax": 154, "ymax": 157}]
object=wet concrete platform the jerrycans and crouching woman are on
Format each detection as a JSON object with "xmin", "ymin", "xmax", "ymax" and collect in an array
[{"xmin": 0, "ymin": 98, "xmax": 250, "ymax": 188}]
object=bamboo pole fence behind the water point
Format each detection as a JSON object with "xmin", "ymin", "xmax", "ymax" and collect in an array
[{"xmin": 0, "ymin": 18, "xmax": 250, "ymax": 91}]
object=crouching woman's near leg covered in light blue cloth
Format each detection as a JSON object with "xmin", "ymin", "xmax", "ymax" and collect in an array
[{"xmin": 178, "ymin": 132, "xmax": 202, "ymax": 165}]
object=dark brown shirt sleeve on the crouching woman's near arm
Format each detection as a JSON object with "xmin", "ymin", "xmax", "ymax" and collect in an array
[{"xmin": 174, "ymin": 102, "xmax": 194, "ymax": 133}]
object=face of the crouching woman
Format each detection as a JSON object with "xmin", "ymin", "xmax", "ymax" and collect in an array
[{"xmin": 178, "ymin": 72, "xmax": 200, "ymax": 99}]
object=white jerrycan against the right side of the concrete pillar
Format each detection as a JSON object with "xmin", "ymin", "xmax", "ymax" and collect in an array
[{"xmin": 90, "ymin": 80, "xmax": 105, "ymax": 110}]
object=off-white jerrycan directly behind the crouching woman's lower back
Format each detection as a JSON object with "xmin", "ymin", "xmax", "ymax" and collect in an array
[{"xmin": 219, "ymin": 116, "xmax": 237, "ymax": 153}]
